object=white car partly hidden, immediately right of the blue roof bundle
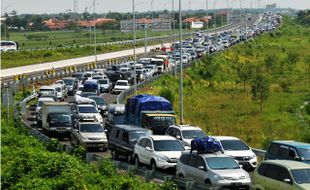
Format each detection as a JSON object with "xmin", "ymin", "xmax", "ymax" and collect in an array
[{"xmin": 212, "ymin": 136, "xmax": 257, "ymax": 170}]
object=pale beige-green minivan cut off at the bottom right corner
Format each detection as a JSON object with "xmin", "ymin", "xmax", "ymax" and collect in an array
[{"xmin": 253, "ymin": 160, "xmax": 310, "ymax": 190}]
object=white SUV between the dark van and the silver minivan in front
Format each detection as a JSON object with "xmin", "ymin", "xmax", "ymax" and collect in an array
[{"xmin": 133, "ymin": 135, "xmax": 184, "ymax": 170}]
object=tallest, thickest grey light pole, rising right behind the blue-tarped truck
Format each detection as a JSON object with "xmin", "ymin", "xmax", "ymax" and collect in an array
[{"xmin": 179, "ymin": 0, "xmax": 183, "ymax": 125}]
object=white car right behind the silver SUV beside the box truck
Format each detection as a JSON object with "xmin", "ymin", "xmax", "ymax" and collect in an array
[{"xmin": 72, "ymin": 103, "xmax": 103, "ymax": 124}]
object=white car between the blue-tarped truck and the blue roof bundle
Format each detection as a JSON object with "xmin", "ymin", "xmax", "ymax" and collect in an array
[{"xmin": 166, "ymin": 125, "xmax": 207, "ymax": 148}]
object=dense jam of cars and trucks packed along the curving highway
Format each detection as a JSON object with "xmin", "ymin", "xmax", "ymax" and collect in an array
[{"xmin": 29, "ymin": 13, "xmax": 310, "ymax": 189}]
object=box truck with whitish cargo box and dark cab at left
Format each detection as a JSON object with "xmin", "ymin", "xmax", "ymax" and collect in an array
[{"xmin": 42, "ymin": 102, "xmax": 73, "ymax": 135}]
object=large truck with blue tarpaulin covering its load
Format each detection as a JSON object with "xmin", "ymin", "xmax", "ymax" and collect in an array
[{"xmin": 125, "ymin": 94, "xmax": 176, "ymax": 135}]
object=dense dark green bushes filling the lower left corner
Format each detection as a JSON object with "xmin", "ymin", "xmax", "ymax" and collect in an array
[{"xmin": 1, "ymin": 91, "xmax": 175, "ymax": 190}]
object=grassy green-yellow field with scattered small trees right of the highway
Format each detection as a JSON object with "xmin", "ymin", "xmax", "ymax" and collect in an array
[{"xmin": 140, "ymin": 17, "xmax": 310, "ymax": 148}]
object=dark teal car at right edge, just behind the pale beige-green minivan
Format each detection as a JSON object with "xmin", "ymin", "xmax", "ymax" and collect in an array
[{"xmin": 265, "ymin": 140, "xmax": 310, "ymax": 164}]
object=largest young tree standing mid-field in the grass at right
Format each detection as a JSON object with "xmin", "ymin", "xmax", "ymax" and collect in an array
[{"xmin": 251, "ymin": 75, "xmax": 270, "ymax": 113}]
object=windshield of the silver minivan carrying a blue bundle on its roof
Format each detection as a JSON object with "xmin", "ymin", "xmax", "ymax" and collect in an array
[{"xmin": 206, "ymin": 157, "xmax": 240, "ymax": 170}]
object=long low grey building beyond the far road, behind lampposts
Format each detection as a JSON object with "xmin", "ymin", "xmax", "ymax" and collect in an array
[{"xmin": 120, "ymin": 14, "xmax": 173, "ymax": 32}]
